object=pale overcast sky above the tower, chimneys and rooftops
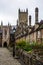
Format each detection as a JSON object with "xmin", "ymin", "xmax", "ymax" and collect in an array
[{"xmin": 0, "ymin": 0, "xmax": 43, "ymax": 25}]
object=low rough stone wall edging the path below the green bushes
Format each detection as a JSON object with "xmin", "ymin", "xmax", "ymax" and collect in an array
[{"xmin": 16, "ymin": 49, "xmax": 43, "ymax": 65}]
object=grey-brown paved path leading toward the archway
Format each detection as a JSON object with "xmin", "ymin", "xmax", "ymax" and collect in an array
[{"xmin": 0, "ymin": 48, "xmax": 21, "ymax": 65}]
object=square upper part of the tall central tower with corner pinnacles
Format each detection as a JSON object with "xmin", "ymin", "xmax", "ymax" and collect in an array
[{"xmin": 18, "ymin": 9, "xmax": 28, "ymax": 25}]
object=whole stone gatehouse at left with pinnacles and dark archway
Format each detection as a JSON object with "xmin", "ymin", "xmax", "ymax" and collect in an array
[{"xmin": 0, "ymin": 22, "xmax": 12, "ymax": 47}]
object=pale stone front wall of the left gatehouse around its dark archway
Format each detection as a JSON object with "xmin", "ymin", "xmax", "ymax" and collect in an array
[{"xmin": 2, "ymin": 26, "xmax": 10, "ymax": 46}]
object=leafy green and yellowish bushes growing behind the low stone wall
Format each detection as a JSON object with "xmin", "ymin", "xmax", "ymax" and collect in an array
[{"xmin": 16, "ymin": 41, "xmax": 43, "ymax": 51}]
